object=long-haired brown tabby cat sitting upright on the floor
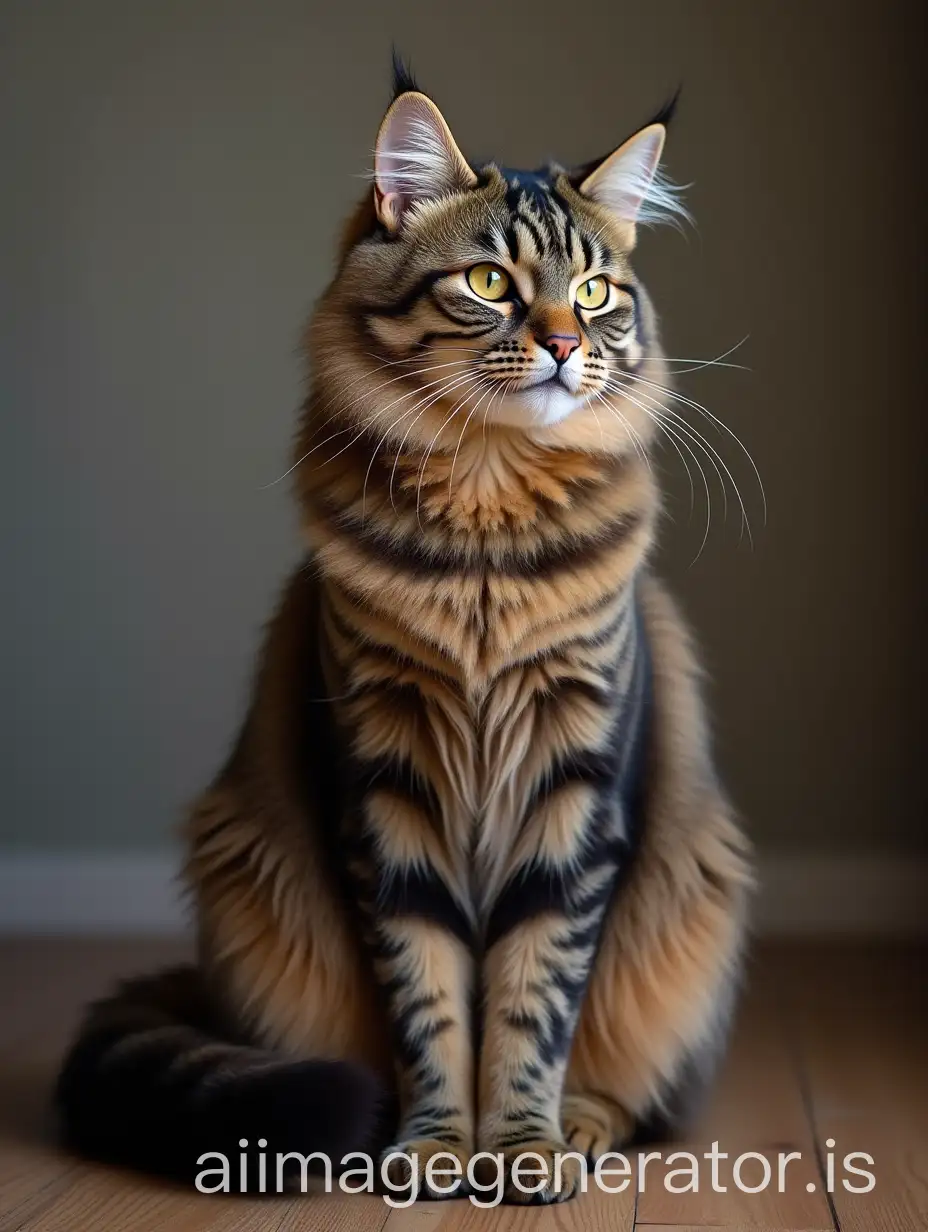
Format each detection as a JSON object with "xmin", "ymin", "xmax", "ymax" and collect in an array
[{"xmin": 58, "ymin": 60, "xmax": 749, "ymax": 1200}]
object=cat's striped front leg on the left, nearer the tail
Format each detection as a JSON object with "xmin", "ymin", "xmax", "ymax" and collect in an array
[{"xmin": 350, "ymin": 792, "xmax": 476, "ymax": 1199}]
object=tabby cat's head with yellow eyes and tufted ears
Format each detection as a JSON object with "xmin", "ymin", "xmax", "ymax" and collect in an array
[{"xmin": 313, "ymin": 60, "xmax": 684, "ymax": 447}]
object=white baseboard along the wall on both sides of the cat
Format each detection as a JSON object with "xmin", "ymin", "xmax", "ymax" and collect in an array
[{"xmin": 0, "ymin": 851, "xmax": 928, "ymax": 938}]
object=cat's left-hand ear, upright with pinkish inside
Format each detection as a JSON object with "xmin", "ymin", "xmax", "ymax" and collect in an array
[{"xmin": 373, "ymin": 90, "xmax": 477, "ymax": 232}]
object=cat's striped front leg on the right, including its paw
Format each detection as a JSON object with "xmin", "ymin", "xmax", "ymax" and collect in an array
[{"xmin": 476, "ymin": 819, "xmax": 616, "ymax": 1202}]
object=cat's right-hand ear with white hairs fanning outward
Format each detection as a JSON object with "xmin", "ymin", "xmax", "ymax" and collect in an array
[{"xmin": 572, "ymin": 123, "xmax": 689, "ymax": 235}]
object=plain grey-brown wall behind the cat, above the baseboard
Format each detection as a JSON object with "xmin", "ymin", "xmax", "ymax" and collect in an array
[{"xmin": 0, "ymin": 0, "xmax": 926, "ymax": 849}]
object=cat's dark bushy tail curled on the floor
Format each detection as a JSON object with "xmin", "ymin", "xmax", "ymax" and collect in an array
[{"xmin": 55, "ymin": 967, "xmax": 383, "ymax": 1189}]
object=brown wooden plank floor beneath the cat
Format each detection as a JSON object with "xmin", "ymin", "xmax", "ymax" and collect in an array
[{"xmin": 0, "ymin": 940, "xmax": 928, "ymax": 1232}]
